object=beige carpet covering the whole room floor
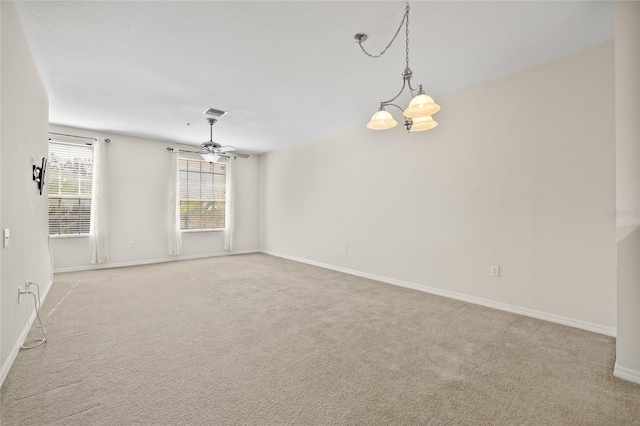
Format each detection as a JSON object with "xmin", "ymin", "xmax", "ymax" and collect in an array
[{"xmin": 1, "ymin": 254, "xmax": 640, "ymax": 426}]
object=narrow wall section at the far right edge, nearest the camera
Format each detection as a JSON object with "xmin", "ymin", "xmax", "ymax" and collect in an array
[{"xmin": 614, "ymin": 1, "xmax": 640, "ymax": 383}]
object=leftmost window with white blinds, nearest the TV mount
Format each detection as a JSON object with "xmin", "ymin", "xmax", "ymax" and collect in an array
[{"xmin": 46, "ymin": 141, "xmax": 93, "ymax": 235}]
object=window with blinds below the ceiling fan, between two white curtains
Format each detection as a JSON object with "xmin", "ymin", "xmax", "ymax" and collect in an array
[{"xmin": 179, "ymin": 158, "xmax": 227, "ymax": 231}]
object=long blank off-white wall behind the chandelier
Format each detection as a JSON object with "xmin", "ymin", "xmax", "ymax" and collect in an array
[{"xmin": 260, "ymin": 43, "xmax": 616, "ymax": 334}]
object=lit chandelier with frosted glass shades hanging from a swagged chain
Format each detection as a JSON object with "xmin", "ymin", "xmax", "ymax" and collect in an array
[{"xmin": 353, "ymin": 2, "xmax": 440, "ymax": 132}]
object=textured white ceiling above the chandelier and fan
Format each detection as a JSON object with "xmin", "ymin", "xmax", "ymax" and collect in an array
[{"xmin": 17, "ymin": 1, "xmax": 614, "ymax": 153}]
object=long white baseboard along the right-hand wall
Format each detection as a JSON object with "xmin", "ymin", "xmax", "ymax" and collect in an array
[{"xmin": 260, "ymin": 250, "xmax": 616, "ymax": 337}]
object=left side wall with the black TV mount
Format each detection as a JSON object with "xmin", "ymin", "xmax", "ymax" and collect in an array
[{"xmin": 0, "ymin": 1, "xmax": 51, "ymax": 383}]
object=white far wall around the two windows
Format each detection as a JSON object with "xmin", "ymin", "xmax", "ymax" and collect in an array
[{"xmin": 50, "ymin": 125, "xmax": 258, "ymax": 270}]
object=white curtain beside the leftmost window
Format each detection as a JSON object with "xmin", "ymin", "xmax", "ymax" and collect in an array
[{"xmin": 89, "ymin": 140, "xmax": 109, "ymax": 264}]
